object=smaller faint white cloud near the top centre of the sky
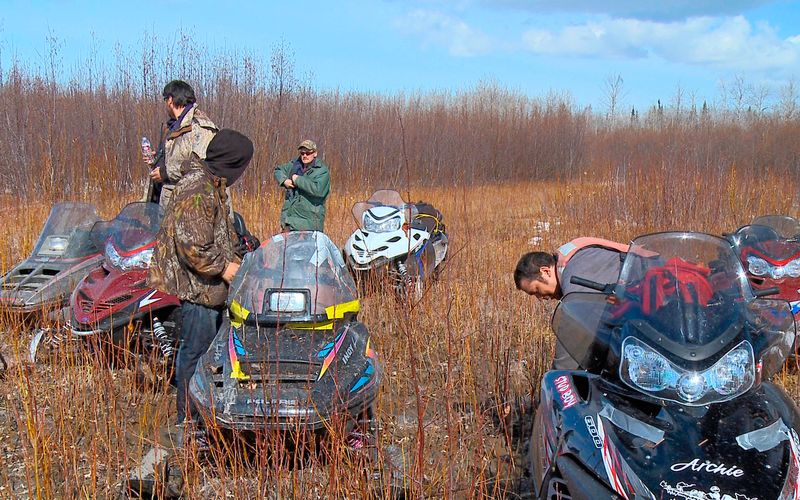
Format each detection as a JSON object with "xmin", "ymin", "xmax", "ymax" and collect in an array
[{"xmin": 394, "ymin": 9, "xmax": 496, "ymax": 57}]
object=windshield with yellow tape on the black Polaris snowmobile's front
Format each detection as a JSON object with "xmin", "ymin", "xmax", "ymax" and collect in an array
[{"xmin": 228, "ymin": 231, "xmax": 358, "ymax": 322}]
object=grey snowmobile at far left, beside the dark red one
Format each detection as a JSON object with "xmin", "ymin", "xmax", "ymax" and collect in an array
[{"xmin": 0, "ymin": 202, "xmax": 103, "ymax": 325}]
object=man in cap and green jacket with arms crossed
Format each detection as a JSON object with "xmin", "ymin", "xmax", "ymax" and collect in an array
[{"xmin": 275, "ymin": 139, "xmax": 331, "ymax": 231}]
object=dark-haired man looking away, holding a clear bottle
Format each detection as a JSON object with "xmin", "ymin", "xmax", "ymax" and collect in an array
[{"xmin": 148, "ymin": 80, "xmax": 217, "ymax": 209}]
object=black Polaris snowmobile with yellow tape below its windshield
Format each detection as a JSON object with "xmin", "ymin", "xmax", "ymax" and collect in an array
[{"xmin": 189, "ymin": 231, "xmax": 381, "ymax": 432}]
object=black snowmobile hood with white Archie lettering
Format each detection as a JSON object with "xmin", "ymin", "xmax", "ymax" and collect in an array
[{"xmin": 543, "ymin": 372, "xmax": 800, "ymax": 499}]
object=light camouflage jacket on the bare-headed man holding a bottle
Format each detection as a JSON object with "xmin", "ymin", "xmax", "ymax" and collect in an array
[{"xmin": 158, "ymin": 105, "xmax": 218, "ymax": 209}]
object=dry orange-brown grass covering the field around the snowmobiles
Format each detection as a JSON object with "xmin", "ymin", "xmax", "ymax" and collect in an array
[{"xmin": 0, "ymin": 167, "xmax": 797, "ymax": 498}]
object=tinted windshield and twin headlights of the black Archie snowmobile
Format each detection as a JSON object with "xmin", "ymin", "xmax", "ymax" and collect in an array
[{"xmin": 553, "ymin": 232, "xmax": 795, "ymax": 405}]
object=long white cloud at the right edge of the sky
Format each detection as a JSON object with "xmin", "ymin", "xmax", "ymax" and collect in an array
[{"xmin": 522, "ymin": 16, "xmax": 800, "ymax": 71}]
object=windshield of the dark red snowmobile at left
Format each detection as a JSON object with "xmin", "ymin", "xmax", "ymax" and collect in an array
[{"xmin": 91, "ymin": 202, "xmax": 161, "ymax": 254}]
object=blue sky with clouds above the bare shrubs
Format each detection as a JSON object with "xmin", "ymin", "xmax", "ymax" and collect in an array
[{"xmin": 0, "ymin": 0, "xmax": 800, "ymax": 110}]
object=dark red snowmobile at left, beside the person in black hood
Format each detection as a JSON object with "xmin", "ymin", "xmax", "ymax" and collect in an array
[{"xmin": 30, "ymin": 202, "xmax": 180, "ymax": 361}]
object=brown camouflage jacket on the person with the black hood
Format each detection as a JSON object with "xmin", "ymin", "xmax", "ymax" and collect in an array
[{"xmin": 147, "ymin": 154, "xmax": 239, "ymax": 307}]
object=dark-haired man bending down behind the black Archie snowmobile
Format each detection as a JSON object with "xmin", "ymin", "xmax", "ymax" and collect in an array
[{"xmin": 514, "ymin": 238, "xmax": 628, "ymax": 370}]
